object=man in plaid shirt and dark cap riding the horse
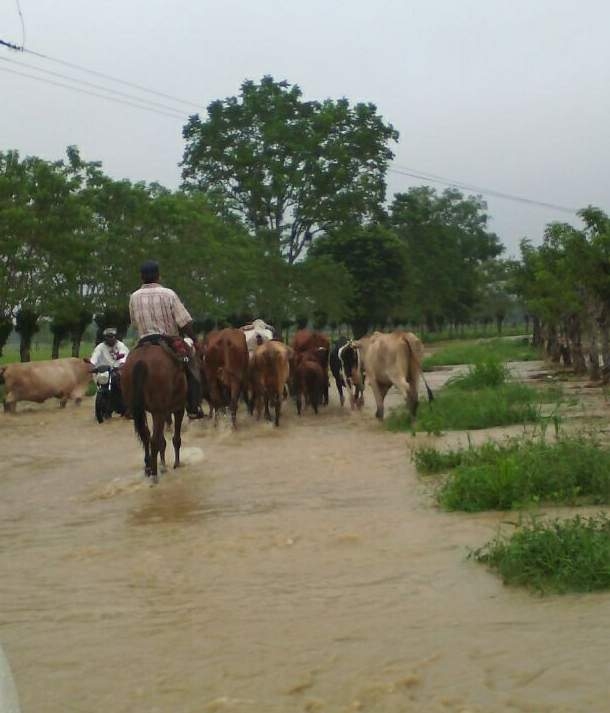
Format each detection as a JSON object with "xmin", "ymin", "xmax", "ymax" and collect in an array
[{"xmin": 129, "ymin": 260, "xmax": 203, "ymax": 418}]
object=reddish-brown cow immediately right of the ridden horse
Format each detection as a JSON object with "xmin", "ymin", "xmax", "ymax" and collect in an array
[{"xmin": 203, "ymin": 328, "xmax": 248, "ymax": 428}]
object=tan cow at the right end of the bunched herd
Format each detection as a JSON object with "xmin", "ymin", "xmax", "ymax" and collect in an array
[{"xmin": 352, "ymin": 331, "xmax": 432, "ymax": 420}]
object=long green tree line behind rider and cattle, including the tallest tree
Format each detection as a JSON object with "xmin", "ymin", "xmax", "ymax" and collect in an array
[{"xmin": 0, "ymin": 77, "xmax": 515, "ymax": 360}]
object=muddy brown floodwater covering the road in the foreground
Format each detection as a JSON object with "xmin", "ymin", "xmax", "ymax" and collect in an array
[{"xmin": 0, "ymin": 364, "xmax": 610, "ymax": 713}]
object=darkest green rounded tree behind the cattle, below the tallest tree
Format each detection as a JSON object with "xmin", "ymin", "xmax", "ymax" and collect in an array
[{"xmin": 310, "ymin": 224, "xmax": 409, "ymax": 338}]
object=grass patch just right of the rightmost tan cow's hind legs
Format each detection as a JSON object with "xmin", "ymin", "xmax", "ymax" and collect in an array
[{"xmin": 386, "ymin": 383, "xmax": 544, "ymax": 434}]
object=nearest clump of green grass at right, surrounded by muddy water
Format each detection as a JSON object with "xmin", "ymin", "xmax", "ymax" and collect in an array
[{"xmin": 472, "ymin": 514, "xmax": 610, "ymax": 593}]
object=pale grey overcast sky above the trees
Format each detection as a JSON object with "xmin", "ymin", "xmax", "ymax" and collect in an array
[{"xmin": 0, "ymin": 0, "xmax": 610, "ymax": 253}]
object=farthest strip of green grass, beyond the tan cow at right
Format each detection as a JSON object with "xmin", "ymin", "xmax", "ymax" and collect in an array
[{"xmin": 424, "ymin": 337, "xmax": 540, "ymax": 371}]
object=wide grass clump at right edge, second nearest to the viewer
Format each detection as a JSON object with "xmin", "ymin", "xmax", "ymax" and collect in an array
[{"xmin": 432, "ymin": 436, "xmax": 610, "ymax": 512}]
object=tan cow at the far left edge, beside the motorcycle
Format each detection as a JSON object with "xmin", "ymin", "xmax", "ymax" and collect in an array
[{"xmin": 0, "ymin": 357, "xmax": 92, "ymax": 413}]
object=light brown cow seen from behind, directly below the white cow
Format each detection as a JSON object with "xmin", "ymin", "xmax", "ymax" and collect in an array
[{"xmin": 250, "ymin": 340, "xmax": 292, "ymax": 426}]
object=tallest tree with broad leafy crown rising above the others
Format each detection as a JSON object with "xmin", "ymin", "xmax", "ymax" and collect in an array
[{"xmin": 182, "ymin": 76, "xmax": 398, "ymax": 263}]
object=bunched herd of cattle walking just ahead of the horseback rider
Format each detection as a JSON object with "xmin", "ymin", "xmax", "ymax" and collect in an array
[{"xmin": 198, "ymin": 320, "xmax": 431, "ymax": 426}]
